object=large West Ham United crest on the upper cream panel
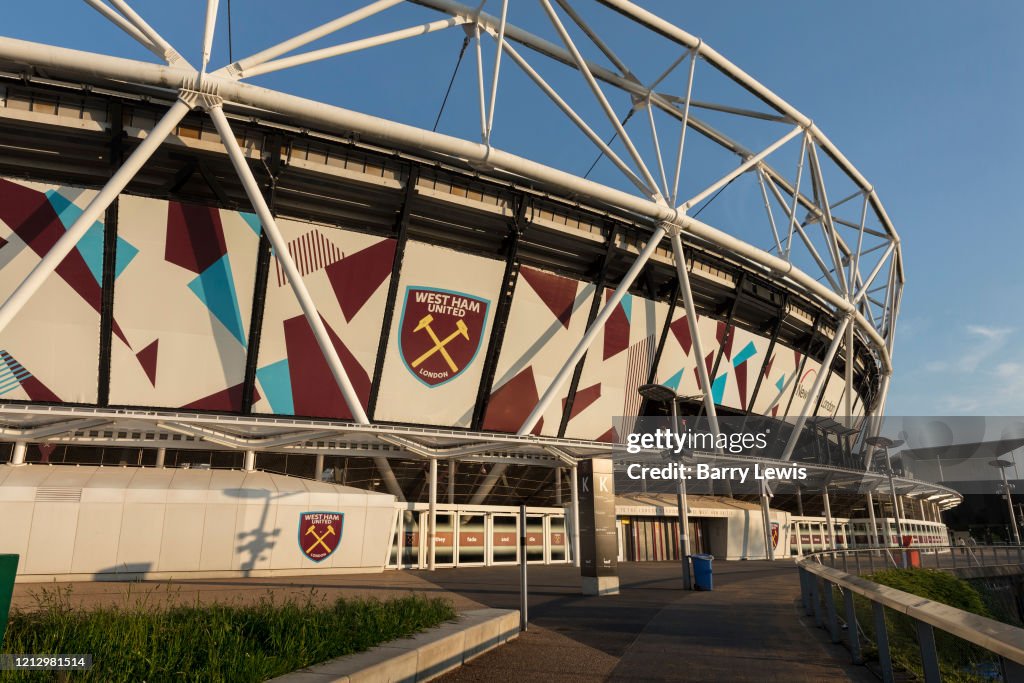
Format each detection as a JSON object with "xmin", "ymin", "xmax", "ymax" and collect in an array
[{"xmin": 398, "ymin": 287, "xmax": 490, "ymax": 387}]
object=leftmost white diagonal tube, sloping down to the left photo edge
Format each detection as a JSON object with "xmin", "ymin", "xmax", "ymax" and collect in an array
[{"xmin": 0, "ymin": 99, "xmax": 191, "ymax": 332}]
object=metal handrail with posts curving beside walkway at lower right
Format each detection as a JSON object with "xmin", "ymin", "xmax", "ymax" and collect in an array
[{"xmin": 797, "ymin": 546, "xmax": 1024, "ymax": 683}]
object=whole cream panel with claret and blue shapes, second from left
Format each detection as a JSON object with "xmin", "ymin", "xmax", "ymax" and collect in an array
[{"xmin": 111, "ymin": 196, "xmax": 260, "ymax": 412}]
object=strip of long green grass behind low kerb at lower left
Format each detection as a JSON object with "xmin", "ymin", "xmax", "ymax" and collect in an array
[{"xmin": 0, "ymin": 591, "xmax": 456, "ymax": 683}]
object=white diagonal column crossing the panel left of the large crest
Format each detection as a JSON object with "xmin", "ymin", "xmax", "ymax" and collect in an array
[{"xmin": 205, "ymin": 104, "xmax": 406, "ymax": 501}]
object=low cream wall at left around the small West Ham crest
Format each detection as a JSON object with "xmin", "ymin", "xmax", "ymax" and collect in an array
[{"xmin": 0, "ymin": 465, "xmax": 395, "ymax": 581}]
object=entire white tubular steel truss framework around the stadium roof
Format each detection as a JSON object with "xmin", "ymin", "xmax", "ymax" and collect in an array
[{"xmin": 0, "ymin": 0, "xmax": 904, "ymax": 481}]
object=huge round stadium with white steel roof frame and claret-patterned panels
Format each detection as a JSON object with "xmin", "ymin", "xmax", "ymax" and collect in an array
[{"xmin": 0, "ymin": 0, "xmax": 961, "ymax": 581}]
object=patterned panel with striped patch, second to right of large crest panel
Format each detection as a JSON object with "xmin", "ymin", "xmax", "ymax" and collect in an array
[{"xmin": 565, "ymin": 289, "xmax": 669, "ymax": 441}]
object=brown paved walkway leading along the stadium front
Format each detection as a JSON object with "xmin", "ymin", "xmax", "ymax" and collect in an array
[{"xmin": 8, "ymin": 561, "xmax": 874, "ymax": 683}]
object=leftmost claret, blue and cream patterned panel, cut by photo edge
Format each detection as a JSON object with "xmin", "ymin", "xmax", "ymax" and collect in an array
[{"xmin": 0, "ymin": 178, "xmax": 102, "ymax": 403}]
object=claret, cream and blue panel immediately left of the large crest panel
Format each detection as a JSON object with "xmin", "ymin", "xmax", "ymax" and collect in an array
[{"xmin": 253, "ymin": 219, "xmax": 395, "ymax": 420}]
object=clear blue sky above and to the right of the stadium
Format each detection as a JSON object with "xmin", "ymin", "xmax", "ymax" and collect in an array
[{"xmin": 8, "ymin": 0, "xmax": 1024, "ymax": 415}]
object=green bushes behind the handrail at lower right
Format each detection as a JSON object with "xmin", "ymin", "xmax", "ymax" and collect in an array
[{"xmin": 836, "ymin": 569, "xmax": 994, "ymax": 682}]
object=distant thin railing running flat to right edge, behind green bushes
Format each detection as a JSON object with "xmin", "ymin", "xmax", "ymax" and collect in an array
[{"xmin": 804, "ymin": 546, "xmax": 1024, "ymax": 574}]
